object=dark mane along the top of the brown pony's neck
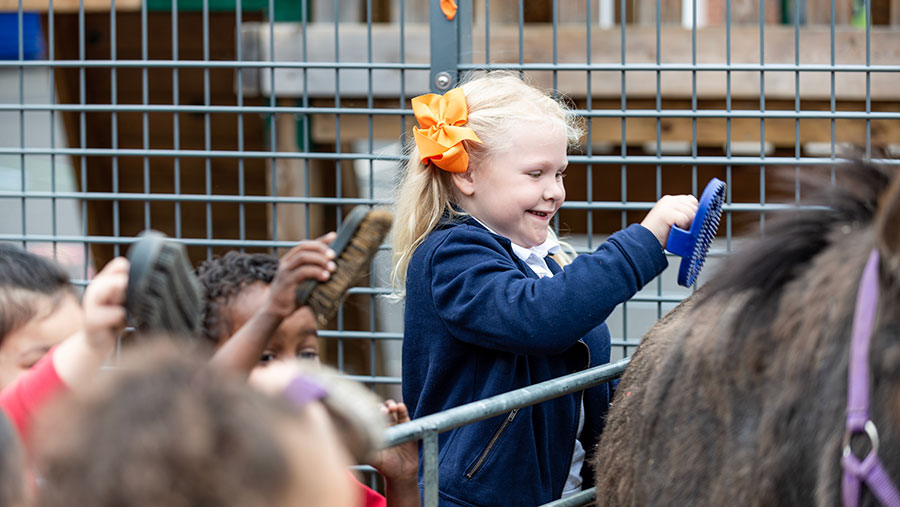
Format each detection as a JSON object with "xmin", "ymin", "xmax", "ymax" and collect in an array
[{"xmin": 702, "ymin": 160, "xmax": 896, "ymax": 306}]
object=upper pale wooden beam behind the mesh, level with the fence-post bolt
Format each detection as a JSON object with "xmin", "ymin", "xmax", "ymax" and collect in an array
[{"xmin": 242, "ymin": 23, "xmax": 900, "ymax": 100}]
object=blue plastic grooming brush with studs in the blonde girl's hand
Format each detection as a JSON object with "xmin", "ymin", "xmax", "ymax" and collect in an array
[{"xmin": 666, "ymin": 178, "xmax": 725, "ymax": 287}]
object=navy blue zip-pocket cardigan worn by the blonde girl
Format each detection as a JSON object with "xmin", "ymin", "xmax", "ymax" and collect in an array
[{"xmin": 402, "ymin": 218, "xmax": 667, "ymax": 506}]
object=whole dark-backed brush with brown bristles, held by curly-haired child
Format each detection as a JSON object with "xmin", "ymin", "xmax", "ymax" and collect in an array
[{"xmin": 296, "ymin": 206, "xmax": 394, "ymax": 326}]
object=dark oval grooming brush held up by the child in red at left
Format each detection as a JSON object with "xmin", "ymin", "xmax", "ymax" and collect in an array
[{"xmin": 125, "ymin": 231, "xmax": 202, "ymax": 337}]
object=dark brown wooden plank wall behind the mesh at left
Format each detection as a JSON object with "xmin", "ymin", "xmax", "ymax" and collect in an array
[{"xmin": 55, "ymin": 13, "xmax": 267, "ymax": 265}]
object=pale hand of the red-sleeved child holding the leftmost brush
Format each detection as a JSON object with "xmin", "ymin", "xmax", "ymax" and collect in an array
[{"xmin": 81, "ymin": 257, "xmax": 129, "ymax": 351}]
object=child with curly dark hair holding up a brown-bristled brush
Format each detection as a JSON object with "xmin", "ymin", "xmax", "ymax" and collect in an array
[{"xmin": 197, "ymin": 240, "xmax": 419, "ymax": 507}]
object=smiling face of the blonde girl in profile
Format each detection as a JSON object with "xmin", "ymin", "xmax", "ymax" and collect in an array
[{"xmin": 453, "ymin": 122, "xmax": 568, "ymax": 248}]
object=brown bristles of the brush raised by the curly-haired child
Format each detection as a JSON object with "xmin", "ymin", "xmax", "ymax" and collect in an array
[{"xmin": 307, "ymin": 210, "xmax": 394, "ymax": 326}]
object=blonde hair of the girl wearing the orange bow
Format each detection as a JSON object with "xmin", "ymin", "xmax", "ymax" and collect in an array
[{"xmin": 391, "ymin": 72, "xmax": 583, "ymax": 298}]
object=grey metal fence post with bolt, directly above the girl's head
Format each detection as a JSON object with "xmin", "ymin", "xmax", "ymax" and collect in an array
[{"xmin": 429, "ymin": 0, "xmax": 472, "ymax": 93}]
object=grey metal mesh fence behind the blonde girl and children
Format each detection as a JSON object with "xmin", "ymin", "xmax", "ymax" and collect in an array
[{"xmin": 0, "ymin": 0, "xmax": 900, "ymax": 396}]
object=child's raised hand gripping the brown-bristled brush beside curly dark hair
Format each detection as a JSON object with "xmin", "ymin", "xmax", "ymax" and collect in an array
[{"xmin": 267, "ymin": 232, "xmax": 337, "ymax": 318}]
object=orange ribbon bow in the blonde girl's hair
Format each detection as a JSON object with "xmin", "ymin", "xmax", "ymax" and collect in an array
[{"xmin": 412, "ymin": 88, "xmax": 481, "ymax": 173}]
